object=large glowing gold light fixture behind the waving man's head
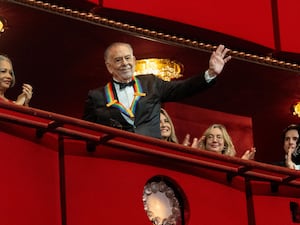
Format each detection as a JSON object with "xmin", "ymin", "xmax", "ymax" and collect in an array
[{"xmin": 134, "ymin": 58, "xmax": 184, "ymax": 81}]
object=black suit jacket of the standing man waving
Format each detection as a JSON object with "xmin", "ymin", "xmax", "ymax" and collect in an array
[{"xmin": 83, "ymin": 74, "xmax": 215, "ymax": 138}]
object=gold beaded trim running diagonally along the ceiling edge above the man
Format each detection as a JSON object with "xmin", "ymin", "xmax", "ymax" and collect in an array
[{"xmin": 6, "ymin": 0, "xmax": 300, "ymax": 72}]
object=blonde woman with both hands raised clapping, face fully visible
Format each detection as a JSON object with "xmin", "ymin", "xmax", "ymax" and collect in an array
[{"xmin": 183, "ymin": 124, "xmax": 256, "ymax": 159}]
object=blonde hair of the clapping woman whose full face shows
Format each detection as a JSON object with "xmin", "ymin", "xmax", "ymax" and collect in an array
[{"xmin": 200, "ymin": 124, "xmax": 236, "ymax": 156}]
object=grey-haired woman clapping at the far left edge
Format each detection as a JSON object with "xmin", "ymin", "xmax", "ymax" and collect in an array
[{"xmin": 0, "ymin": 55, "xmax": 32, "ymax": 106}]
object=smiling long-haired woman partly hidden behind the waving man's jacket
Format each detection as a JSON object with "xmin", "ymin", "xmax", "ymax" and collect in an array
[{"xmin": 160, "ymin": 108, "xmax": 178, "ymax": 143}]
